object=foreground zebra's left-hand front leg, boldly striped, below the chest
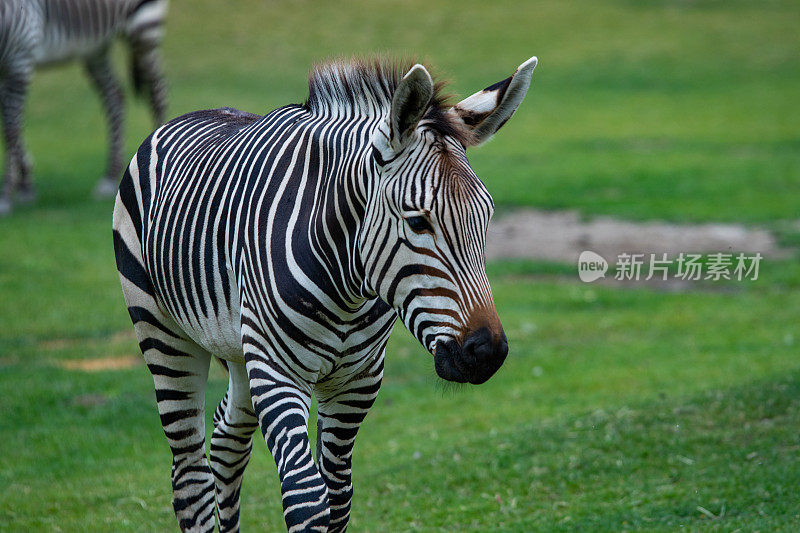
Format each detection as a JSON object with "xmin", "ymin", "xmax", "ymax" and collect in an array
[{"xmin": 247, "ymin": 357, "xmax": 330, "ymax": 532}]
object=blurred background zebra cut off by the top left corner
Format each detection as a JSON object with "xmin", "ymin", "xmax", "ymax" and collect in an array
[{"xmin": 0, "ymin": 0, "xmax": 167, "ymax": 215}]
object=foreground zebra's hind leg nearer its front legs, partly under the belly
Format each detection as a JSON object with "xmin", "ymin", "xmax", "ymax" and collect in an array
[{"xmin": 209, "ymin": 361, "xmax": 258, "ymax": 532}]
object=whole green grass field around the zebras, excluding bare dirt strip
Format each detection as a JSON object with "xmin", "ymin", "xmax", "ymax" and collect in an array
[{"xmin": 0, "ymin": 0, "xmax": 800, "ymax": 531}]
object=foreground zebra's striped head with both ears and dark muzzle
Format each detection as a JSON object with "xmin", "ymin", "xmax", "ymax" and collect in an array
[{"xmin": 359, "ymin": 57, "xmax": 537, "ymax": 384}]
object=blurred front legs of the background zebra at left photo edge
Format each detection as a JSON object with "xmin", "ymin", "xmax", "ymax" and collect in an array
[{"xmin": 0, "ymin": 67, "xmax": 35, "ymax": 215}]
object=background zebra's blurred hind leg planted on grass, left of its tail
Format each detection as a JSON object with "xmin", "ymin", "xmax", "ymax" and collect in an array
[{"xmin": 86, "ymin": 48, "xmax": 125, "ymax": 198}]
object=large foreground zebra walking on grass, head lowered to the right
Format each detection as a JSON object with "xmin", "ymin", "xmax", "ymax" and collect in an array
[{"xmin": 113, "ymin": 57, "xmax": 537, "ymax": 531}]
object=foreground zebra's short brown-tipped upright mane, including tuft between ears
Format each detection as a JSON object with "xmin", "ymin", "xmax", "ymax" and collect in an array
[{"xmin": 303, "ymin": 57, "xmax": 471, "ymax": 145}]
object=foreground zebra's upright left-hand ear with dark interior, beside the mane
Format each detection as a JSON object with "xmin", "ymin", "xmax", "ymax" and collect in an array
[{"xmin": 389, "ymin": 63, "xmax": 433, "ymax": 152}]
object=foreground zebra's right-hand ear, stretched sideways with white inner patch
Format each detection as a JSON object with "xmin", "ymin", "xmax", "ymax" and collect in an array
[{"xmin": 448, "ymin": 56, "xmax": 538, "ymax": 146}]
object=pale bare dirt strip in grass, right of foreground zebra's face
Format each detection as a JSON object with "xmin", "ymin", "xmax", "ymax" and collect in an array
[{"xmin": 486, "ymin": 209, "xmax": 786, "ymax": 263}]
